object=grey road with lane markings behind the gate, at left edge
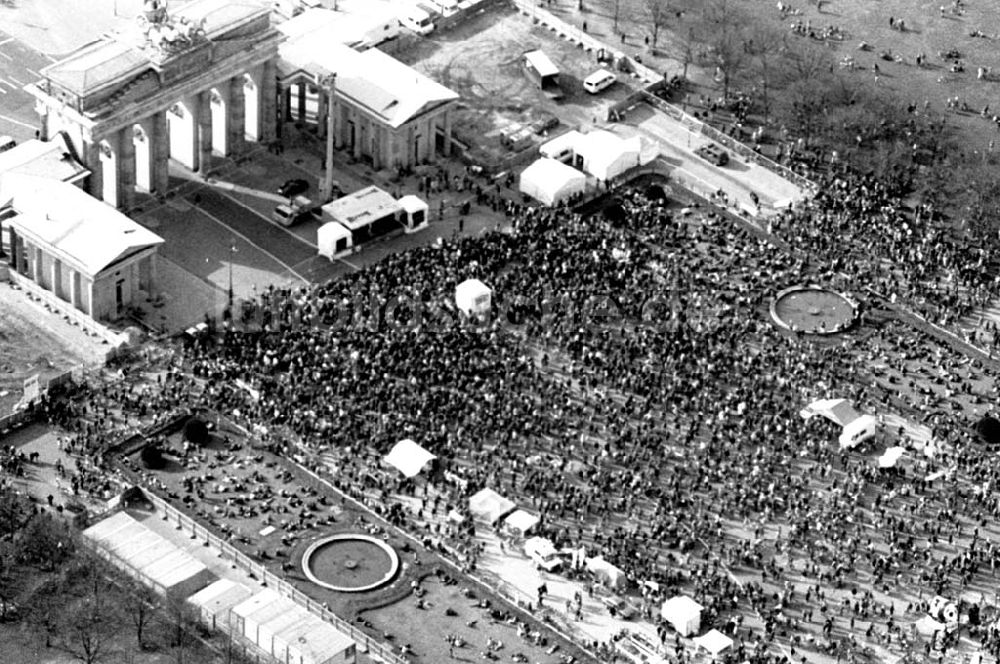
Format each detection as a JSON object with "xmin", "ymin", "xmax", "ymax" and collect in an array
[{"xmin": 0, "ymin": 32, "xmax": 52, "ymax": 142}]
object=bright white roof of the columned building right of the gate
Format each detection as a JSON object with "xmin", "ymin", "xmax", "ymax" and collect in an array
[{"xmin": 278, "ymin": 36, "xmax": 458, "ymax": 128}]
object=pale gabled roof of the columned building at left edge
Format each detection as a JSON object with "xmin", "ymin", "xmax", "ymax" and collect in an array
[{"xmin": 0, "ymin": 173, "xmax": 163, "ymax": 277}]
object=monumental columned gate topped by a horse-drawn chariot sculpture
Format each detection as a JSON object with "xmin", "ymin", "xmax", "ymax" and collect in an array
[{"xmin": 25, "ymin": 0, "xmax": 284, "ymax": 209}]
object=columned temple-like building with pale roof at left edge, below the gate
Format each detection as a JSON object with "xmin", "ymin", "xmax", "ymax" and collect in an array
[{"xmin": 0, "ymin": 173, "xmax": 163, "ymax": 321}]
